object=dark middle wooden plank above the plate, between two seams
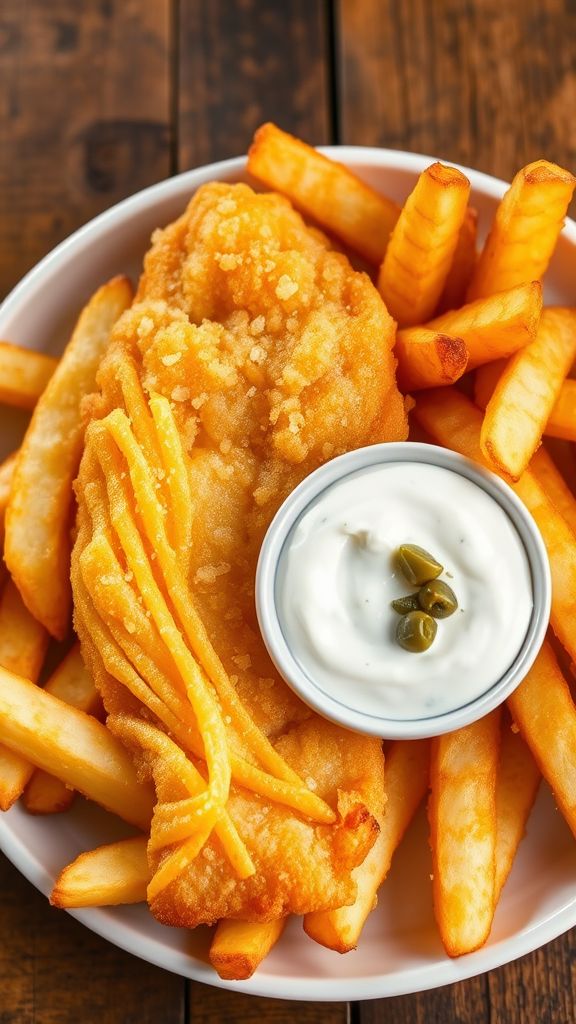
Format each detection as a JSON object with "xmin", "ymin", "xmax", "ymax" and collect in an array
[{"xmin": 178, "ymin": 0, "xmax": 331, "ymax": 170}]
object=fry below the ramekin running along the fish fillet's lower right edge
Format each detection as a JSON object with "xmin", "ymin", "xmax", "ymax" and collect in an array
[{"xmin": 304, "ymin": 739, "xmax": 429, "ymax": 953}]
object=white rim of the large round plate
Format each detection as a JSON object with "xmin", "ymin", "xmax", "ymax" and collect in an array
[{"xmin": 0, "ymin": 145, "xmax": 576, "ymax": 1002}]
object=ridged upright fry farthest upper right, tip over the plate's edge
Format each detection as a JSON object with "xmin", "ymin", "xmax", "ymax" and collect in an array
[{"xmin": 468, "ymin": 160, "xmax": 576, "ymax": 300}]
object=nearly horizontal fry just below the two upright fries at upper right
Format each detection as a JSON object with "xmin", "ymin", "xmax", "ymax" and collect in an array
[{"xmin": 397, "ymin": 283, "xmax": 542, "ymax": 370}]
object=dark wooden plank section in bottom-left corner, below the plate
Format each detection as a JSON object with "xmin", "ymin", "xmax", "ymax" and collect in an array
[{"xmin": 0, "ymin": 854, "xmax": 184, "ymax": 1024}]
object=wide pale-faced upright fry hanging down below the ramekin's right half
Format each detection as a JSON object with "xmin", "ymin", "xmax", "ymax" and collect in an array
[{"xmin": 428, "ymin": 711, "xmax": 500, "ymax": 956}]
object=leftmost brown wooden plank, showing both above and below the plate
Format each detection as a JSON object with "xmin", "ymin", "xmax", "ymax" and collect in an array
[{"xmin": 0, "ymin": 0, "xmax": 181, "ymax": 1024}]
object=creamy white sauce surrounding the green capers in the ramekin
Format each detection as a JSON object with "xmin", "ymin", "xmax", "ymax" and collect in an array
[{"xmin": 276, "ymin": 462, "xmax": 532, "ymax": 720}]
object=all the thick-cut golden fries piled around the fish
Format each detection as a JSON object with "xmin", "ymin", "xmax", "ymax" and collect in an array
[{"xmin": 0, "ymin": 124, "xmax": 576, "ymax": 979}]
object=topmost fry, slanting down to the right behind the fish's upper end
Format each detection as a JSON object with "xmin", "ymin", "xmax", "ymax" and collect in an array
[{"xmin": 248, "ymin": 124, "xmax": 400, "ymax": 264}]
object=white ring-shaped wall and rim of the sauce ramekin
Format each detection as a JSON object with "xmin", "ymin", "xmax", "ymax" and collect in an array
[{"xmin": 256, "ymin": 441, "xmax": 551, "ymax": 739}]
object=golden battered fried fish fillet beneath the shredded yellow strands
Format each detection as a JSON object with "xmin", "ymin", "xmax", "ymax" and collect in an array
[{"xmin": 73, "ymin": 183, "xmax": 407, "ymax": 927}]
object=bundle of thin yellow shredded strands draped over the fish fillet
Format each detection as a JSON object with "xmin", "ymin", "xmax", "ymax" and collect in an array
[{"xmin": 78, "ymin": 372, "xmax": 335, "ymax": 901}]
